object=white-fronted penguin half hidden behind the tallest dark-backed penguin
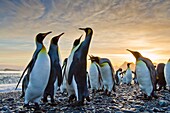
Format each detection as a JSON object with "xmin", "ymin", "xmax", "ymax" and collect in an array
[{"xmin": 65, "ymin": 35, "xmax": 82, "ymax": 102}]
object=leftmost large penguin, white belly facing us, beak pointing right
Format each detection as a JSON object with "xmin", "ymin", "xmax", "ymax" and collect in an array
[{"xmin": 16, "ymin": 32, "xmax": 51, "ymax": 109}]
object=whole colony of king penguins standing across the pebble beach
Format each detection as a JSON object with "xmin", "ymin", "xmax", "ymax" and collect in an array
[{"xmin": 16, "ymin": 27, "xmax": 170, "ymax": 110}]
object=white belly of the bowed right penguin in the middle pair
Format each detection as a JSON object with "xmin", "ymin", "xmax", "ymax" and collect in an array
[{"xmin": 101, "ymin": 64, "xmax": 113, "ymax": 91}]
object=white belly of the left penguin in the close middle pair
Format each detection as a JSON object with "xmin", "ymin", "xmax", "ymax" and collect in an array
[{"xmin": 89, "ymin": 63, "xmax": 99, "ymax": 90}]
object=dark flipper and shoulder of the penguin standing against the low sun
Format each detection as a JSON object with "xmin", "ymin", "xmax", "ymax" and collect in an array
[{"xmin": 139, "ymin": 58, "xmax": 156, "ymax": 91}]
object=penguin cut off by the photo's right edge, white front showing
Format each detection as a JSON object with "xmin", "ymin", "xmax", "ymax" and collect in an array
[{"xmin": 164, "ymin": 59, "xmax": 170, "ymax": 91}]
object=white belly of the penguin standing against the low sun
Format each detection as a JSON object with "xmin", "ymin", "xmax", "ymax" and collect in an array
[{"xmin": 136, "ymin": 60, "xmax": 153, "ymax": 96}]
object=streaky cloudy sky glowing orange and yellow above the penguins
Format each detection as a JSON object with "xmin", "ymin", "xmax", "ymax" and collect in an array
[{"xmin": 0, "ymin": 0, "xmax": 170, "ymax": 68}]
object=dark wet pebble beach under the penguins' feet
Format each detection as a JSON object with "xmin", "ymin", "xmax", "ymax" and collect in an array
[{"xmin": 0, "ymin": 84, "xmax": 170, "ymax": 113}]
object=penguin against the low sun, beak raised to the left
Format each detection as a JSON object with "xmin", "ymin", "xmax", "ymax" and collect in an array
[{"xmin": 127, "ymin": 49, "xmax": 157, "ymax": 99}]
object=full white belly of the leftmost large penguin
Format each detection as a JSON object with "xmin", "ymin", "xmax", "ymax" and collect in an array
[{"xmin": 25, "ymin": 51, "xmax": 51, "ymax": 103}]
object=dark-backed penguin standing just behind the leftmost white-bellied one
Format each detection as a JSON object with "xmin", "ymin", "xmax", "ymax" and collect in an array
[{"xmin": 43, "ymin": 33, "xmax": 64, "ymax": 104}]
